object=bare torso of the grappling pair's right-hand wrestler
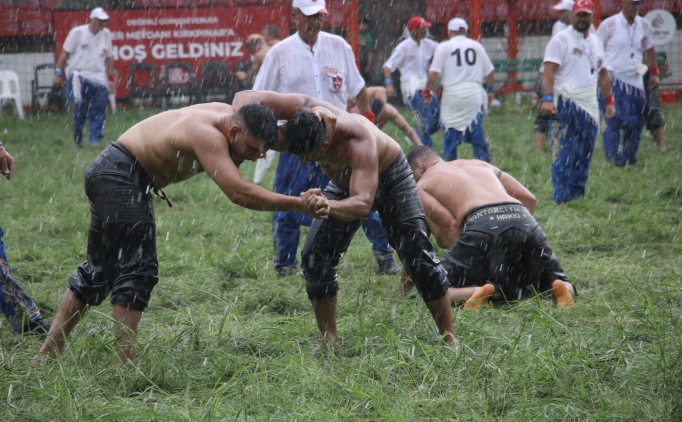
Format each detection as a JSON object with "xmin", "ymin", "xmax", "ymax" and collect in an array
[{"xmin": 317, "ymin": 112, "xmax": 402, "ymax": 189}]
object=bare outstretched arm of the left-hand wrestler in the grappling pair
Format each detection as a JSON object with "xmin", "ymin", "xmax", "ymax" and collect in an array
[{"xmin": 191, "ymin": 126, "xmax": 320, "ymax": 213}]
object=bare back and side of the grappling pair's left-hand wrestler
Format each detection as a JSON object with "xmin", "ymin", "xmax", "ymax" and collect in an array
[{"xmin": 118, "ymin": 103, "xmax": 239, "ymax": 188}]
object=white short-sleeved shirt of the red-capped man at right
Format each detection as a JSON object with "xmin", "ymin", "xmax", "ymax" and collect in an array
[{"xmin": 544, "ymin": 26, "xmax": 606, "ymax": 91}]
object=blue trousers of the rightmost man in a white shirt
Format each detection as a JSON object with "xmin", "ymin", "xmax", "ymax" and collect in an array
[{"xmin": 599, "ymin": 75, "xmax": 646, "ymax": 166}]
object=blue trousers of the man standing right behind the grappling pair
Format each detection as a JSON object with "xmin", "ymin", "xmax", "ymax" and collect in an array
[{"xmin": 272, "ymin": 152, "xmax": 393, "ymax": 270}]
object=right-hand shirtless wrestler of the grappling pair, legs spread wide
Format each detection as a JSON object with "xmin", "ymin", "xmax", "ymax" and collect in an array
[{"xmin": 233, "ymin": 91, "xmax": 455, "ymax": 354}]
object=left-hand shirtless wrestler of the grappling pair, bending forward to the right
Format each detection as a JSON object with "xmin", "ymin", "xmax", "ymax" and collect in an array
[{"xmin": 33, "ymin": 103, "xmax": 328, "ymax": 366}]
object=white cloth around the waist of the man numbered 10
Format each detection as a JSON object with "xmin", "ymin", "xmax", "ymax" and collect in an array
[{"xmin": 440, "ymin": 82, "xmax": 488, "ymax": 132}]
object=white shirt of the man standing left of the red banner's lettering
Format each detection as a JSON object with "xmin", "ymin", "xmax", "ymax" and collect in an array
[{"xmin": 63, "ymin": 25, "xmax": 112, "ymax": 85}]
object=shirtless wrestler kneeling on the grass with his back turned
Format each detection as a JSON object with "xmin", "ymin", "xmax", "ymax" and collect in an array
[{"xmin": 403, "ymin": 147, "xmax": 576, "ymax": 309}]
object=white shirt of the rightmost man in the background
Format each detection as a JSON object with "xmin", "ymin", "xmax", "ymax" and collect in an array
[{"xmin": 597, "ymin": 12, "xmax": 654, "ymax": 89}]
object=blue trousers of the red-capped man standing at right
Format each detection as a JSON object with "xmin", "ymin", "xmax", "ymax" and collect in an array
[{"xmin": 549, "ymin": 98, "xmax": 598, "ymax": 202}]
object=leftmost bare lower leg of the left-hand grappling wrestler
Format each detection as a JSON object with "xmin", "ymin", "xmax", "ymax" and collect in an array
[{"xmin": 31, "ymin": 289, "xmax": 85, "ymax": 368}]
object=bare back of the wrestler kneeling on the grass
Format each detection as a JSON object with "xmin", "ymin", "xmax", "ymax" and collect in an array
[{"xmin": 417, "ymin": 160, "xmax": 521, "ymax": 228}]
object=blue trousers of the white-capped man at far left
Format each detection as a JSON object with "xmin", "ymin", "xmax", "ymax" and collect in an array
[{"xmin": 66, "ymin": 75, "xmax": 109, "ymax": 145}]
